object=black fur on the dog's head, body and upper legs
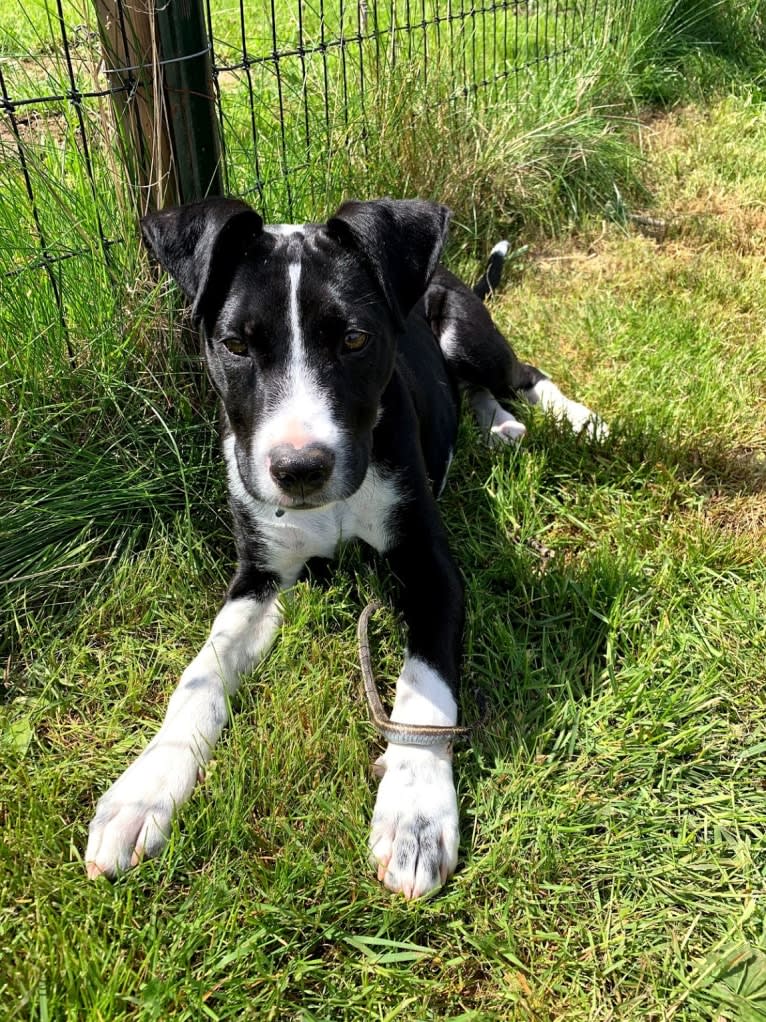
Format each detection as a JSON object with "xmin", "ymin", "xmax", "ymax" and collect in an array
[{"xmin": 143, "ymin": 199, "xmax": 542, "ymax": 707}]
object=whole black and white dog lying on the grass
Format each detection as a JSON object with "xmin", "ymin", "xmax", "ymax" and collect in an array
[{"xmin": 86, "ymin": 199, "xmax": 603, "ymax": 898}]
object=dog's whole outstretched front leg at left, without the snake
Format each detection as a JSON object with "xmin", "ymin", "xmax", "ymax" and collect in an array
[{"xmin": 85, "ymin": 572, "xmax": 280, "ymax": 877}]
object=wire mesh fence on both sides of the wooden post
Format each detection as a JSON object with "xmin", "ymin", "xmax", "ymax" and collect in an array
[{"xmin": 0, "ymin": 0, "xmax": 607, "ymax": 335}]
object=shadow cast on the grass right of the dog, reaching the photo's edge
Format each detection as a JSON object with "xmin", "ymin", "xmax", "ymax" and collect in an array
[{"xmin": 433, "ymin": 412, "xmax": 766, "ymax": 747}]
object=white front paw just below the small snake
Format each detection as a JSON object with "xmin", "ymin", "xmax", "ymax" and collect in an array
[{"xmin": 370, "ymin": 745, "xmax": 460, "ymax": 898}]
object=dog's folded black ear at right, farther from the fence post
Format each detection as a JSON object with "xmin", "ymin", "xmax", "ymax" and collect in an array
[{"xmin": 327, "ymin": 198, "xmax": 449, "ymax": 326}]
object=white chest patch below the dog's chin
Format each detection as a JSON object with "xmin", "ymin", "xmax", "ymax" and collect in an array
[{"xmin": 252, "ymin": 467, "xmax": 399, "ymax": 575}]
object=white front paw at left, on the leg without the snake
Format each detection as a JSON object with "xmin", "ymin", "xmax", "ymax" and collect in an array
[{"xmin": 85, "ymin": 744, "xmax": 198, "ymax": 879}]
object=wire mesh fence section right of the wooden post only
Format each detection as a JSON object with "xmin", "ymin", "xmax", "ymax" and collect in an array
[{"xmin": 208, "ymin": 0, "xmax": 597, "ymax": 219}]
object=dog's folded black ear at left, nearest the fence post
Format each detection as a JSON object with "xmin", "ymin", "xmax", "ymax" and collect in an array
[{"xmin": 141, "ymin": 198, "xmax": 264, "ymax": 317}]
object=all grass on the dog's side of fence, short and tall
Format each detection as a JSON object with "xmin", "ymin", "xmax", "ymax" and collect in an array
[{"xmin": 0, "ymin": 0, "xmax": 766, "ymax": 1022}]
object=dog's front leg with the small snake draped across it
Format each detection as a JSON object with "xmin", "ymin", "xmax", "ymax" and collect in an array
[{"xmin": 370, "ymin": 523, "xmax": 464, "ymax": 898}]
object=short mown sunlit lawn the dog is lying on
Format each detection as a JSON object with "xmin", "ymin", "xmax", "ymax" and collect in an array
[{"xmin": 0, "ymin": 91, "xmax": 766, "ymax": 1022}]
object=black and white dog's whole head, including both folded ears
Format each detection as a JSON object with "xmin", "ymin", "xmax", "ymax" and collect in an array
[{"xmin": 141, "ymin": 199, "xmax": 449, "ymax": 508}]
